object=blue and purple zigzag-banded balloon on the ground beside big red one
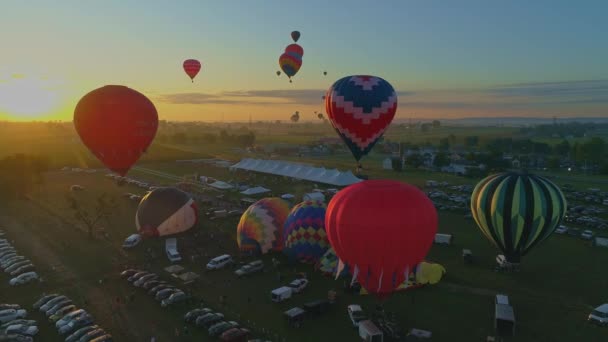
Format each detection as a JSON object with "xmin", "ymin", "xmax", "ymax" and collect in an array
[{"xmin": 283, "ymin": 201, "xmax": 329, "ymax": 263}]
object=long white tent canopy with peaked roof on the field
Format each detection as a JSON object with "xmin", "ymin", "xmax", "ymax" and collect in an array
[{"xmin": 230, "ymin": 158, "xmax": 361, "ymax": 186}]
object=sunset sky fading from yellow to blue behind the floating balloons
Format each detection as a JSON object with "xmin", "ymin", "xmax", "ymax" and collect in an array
[{"xmin": 0, "ymin": 0, "xmax": 608, "ymax": 121}]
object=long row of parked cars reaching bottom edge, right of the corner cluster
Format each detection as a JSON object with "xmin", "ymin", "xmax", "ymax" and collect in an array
[{"xmin": 33, "ymin": 293, "xmax": 112, "ymax": 342}]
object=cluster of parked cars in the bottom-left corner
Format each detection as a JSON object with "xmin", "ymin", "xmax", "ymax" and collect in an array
[{"xmin": 0, "ymin": 304, "xmax": 38, "ymax": 342}]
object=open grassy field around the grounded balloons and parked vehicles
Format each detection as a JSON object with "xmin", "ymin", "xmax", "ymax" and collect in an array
[{"xmin": 0, "ymin": 162, "xmax": 608, "ymax": 342}]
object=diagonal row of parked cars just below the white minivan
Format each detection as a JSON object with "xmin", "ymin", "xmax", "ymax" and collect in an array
[{"xmin": 120, "ymin": 269, "xmax": 190, "ymax": 308}]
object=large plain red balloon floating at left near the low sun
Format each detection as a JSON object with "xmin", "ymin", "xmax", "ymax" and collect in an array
[{"xmin": 74, "ymin": 85, "xmax": 158, "ymax": 176}]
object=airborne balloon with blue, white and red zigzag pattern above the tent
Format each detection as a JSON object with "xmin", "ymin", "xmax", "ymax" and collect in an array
[{"xmin": 325, "ymin": 75, "xmax": 397, "ymax": 161}]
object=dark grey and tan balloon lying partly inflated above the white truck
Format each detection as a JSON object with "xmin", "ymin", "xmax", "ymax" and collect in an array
[{"xmin": 135, "ymin": 187, "xmax": 198, "ymax": 237}]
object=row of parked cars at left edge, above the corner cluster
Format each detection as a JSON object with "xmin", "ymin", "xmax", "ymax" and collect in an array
[{"xmin": 0, "ymin": 231, "xmax": 39, "ymax": 286}]
